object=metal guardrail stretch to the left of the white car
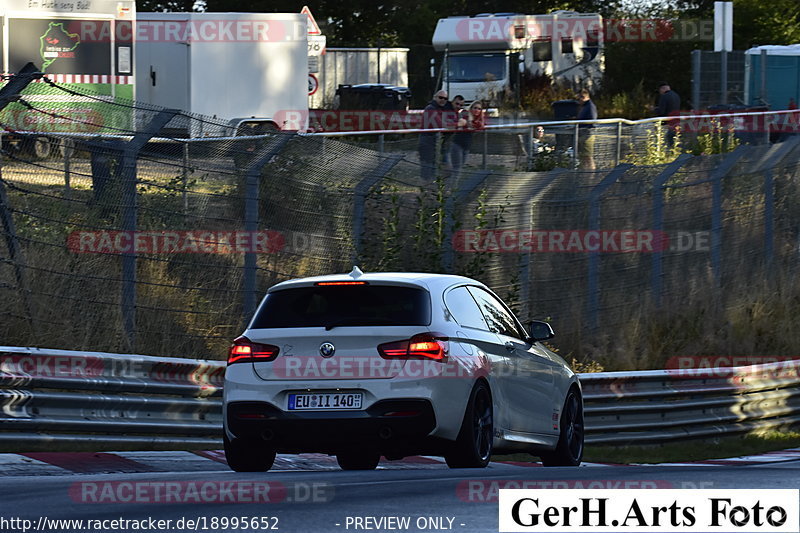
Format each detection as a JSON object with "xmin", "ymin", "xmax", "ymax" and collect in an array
[{"xmin": 0, "ymin": 347, "xmax": 225, "ymax": 451}]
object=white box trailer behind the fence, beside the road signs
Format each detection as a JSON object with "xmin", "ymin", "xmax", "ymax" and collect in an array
[{"xmin": 136, "ymin": 13, "xmax": 308, "ymax": 137}]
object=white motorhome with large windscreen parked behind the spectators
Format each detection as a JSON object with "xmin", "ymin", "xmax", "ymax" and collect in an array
[{"xmin": 433, "ymin": 11, "xmax": 603, "ymax": 106}]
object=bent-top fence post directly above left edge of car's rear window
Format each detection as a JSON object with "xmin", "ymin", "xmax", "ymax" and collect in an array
[{"xmin": 242, "ymin": 133, "xmax": 295, "ymax": 324}]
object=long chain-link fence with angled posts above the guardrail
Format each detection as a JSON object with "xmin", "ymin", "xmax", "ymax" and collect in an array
[{"xmin": 0, "ymin": 67, "xmax": 800, "ymax": 366}]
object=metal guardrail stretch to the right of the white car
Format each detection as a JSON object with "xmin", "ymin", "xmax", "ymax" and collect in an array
[{"xmin": 581, "ymin": 361, "xmax": 800, "ymax": 445}]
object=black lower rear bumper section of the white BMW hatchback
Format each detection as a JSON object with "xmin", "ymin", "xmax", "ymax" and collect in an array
[{"xmin": 225, "ymin": 399, "xmax": 436, "ymax": 455}]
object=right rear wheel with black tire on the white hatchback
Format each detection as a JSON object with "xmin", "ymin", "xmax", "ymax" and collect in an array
[{"xmin": 444, "ymin": 381, "xmax": 494, "ymax": 468}]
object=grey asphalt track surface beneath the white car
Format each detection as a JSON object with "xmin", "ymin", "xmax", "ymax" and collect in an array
[{"xmin": 0, "ymin": 454, "xmax": 800, "ymax": 533}]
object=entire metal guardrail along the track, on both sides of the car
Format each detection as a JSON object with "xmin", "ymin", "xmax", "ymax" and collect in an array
[{"xmin": 0, "ymin": 347, "xmax": 800, "ymax": 451}]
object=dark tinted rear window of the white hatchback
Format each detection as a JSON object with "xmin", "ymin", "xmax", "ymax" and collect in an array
[{"xmin": 251, "ymin": 285, "xmax": 431, "ymax": 328}]
